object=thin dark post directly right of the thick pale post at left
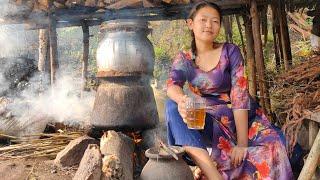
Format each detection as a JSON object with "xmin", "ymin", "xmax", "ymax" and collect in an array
[{"xmin": 48, "ymin": 0, "xmax": 59, "ymax": 85}]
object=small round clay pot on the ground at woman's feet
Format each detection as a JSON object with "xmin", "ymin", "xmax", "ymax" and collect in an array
[{"xmin": 140, "ymin": 146, "xmax": 194, "ymax": 180}]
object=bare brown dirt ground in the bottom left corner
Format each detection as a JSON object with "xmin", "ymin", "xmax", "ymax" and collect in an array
[{"xmin": 0, "ymin": 158, "xmax": 77, "ymax": 180}]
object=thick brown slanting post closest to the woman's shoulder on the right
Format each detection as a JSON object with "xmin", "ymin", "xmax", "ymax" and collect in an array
[{"xmin": 242, "ymin": 14, "xmax": 257, "ymax": 99}]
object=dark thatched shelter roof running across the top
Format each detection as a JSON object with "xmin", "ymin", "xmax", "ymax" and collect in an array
[{"xmin": 0, "ymin": 0, "xmax": 318, "ymax": 28}]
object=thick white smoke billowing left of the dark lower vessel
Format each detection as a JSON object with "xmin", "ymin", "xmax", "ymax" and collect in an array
[{"xmin": 0, "ymin": 70, "xmax": 94, "ymax": 136}]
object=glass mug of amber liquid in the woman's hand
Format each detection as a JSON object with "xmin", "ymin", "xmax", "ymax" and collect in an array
[{"xmin": 186, "ymin": 97, "xmax": 206, "ymax": 129}]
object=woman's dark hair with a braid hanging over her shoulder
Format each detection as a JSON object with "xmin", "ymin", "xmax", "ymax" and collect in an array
[{"xmin": 188, "ymin": 1, "xmax": 222, "ymax": 63}]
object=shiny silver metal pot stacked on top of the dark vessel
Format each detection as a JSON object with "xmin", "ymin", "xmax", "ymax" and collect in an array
[{"xmin": 97, "ymin": 20, "xmax": 154, "ymax": 77}]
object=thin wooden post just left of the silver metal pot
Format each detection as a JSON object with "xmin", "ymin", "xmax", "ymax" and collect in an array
[{"xmin": 82, "ymin": 22, "xmax": 89, "ymax": 93}]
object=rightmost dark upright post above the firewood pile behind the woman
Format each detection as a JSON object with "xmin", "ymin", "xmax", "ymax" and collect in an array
[{"xmin": 277, "ymin": 1, "xmax": 292, "ymax": 70}]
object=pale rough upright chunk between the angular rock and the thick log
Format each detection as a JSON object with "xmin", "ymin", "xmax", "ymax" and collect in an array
[{"xmin": 73, "ymin": 144, "xmax": 102, "ymax": 180}]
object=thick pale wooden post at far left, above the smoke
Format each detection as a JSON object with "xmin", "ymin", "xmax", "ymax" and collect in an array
[{"xmin": 38, "ymin": 29, "xmax": 50, "ymax": 73}]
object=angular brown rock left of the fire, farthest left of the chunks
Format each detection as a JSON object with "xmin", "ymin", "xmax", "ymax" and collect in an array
[{"xmin": 54, "ymin": 136, "xmax": 99, "ymax": 167}]
